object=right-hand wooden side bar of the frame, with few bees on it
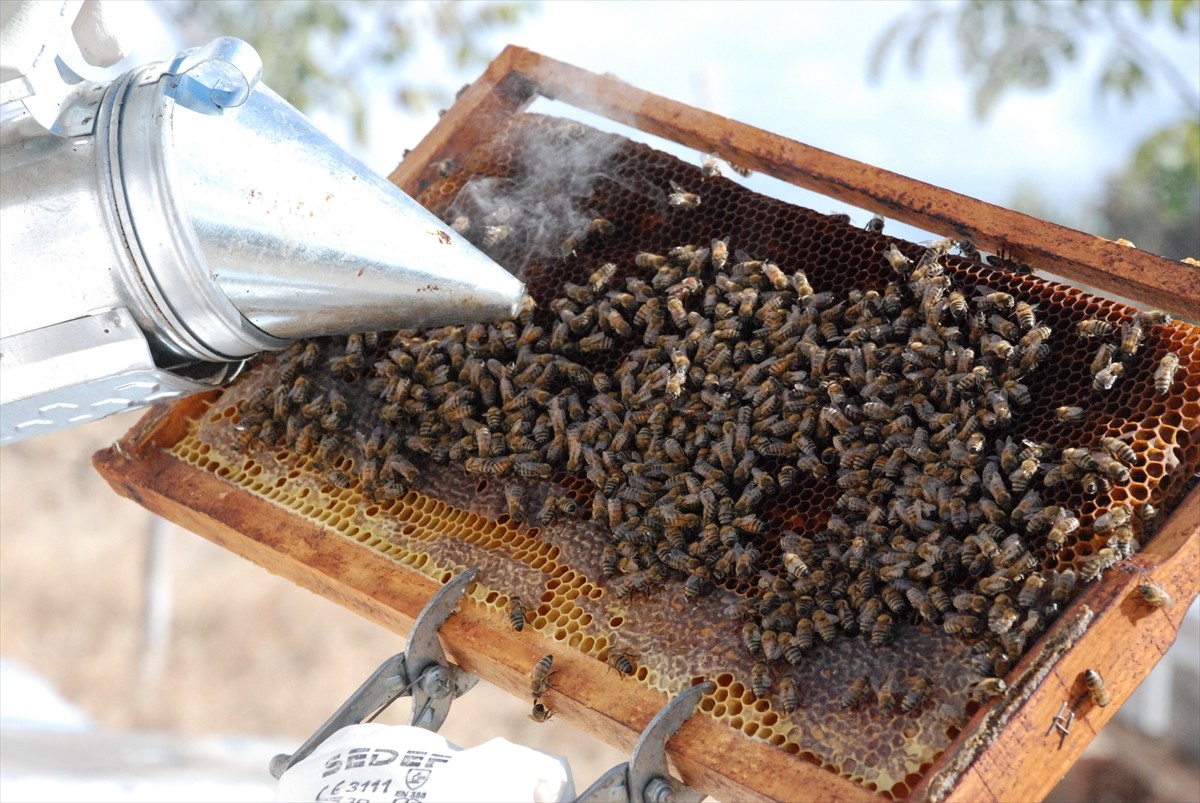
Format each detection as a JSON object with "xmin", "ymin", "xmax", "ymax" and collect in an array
[{"xmin": 911, "ymin": 487, "xmax": 1200, "ymax": 802}]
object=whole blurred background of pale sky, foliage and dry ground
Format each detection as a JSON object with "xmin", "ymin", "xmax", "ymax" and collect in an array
[{"xmin": 0, "ymin": 0, "xmax": 1200, "ymax": 801}]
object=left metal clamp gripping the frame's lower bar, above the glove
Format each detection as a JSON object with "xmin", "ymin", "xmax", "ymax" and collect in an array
[{"xmin": 270, "ymin": 569, "xmax": 480, "ymax": 777}]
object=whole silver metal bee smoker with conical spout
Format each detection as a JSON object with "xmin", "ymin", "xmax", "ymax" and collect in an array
[{"xmin": 0, "ymin": 37, "xmax": 524, "ymax": 443}]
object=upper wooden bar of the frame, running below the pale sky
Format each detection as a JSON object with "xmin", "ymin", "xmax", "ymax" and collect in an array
[{"xmin": 484, "ymin": 46, "xmax": 1200, "ymax": 320}]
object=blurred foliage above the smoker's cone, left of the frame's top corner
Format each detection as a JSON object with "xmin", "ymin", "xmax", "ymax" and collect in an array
[{"xmin": 168, "ymin": 0, "xmax": 533, "ymax": 142}]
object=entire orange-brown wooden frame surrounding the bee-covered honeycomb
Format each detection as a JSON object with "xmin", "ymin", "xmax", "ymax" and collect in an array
[{"xmin": 95, "ymin": 47, "xmax": 1200, "ymax": 801}]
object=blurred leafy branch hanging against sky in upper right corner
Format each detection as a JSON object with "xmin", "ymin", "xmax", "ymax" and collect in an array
[{"xmin": 870, "ymin": 0, "xmax": 1200, "ymax": 118}]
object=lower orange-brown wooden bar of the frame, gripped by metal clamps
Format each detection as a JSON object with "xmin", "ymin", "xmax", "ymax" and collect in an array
[{"xmin": 92, "ymin": 432, "xmax": 880, "ymax": 801}]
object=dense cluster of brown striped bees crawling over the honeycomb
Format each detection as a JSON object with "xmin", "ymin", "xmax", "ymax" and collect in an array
[{"xmin": 239, "ymin": 186, "xmax": 1177, "ymax": 719}]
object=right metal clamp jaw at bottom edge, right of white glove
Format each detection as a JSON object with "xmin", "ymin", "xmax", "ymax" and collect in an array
[{"xmin": 576, "ymin": 681, "xmax": 716, "ymax": 803}]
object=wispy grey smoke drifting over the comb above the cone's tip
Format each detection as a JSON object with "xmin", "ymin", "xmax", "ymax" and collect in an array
[{"xmin": 446, "ymin": 118, "xmax": 665, "ymax": 278}]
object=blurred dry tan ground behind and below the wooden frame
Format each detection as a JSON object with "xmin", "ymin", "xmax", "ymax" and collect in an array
[{"xmin": 0, "ymin": 413, "xmax": 1200, "ymax": 801}]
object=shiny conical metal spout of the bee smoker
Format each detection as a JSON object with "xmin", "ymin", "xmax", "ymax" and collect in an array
[{"xmin": 174, "ymin": 85, "xmax": 524, "ymax": 338}]
